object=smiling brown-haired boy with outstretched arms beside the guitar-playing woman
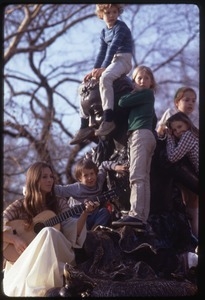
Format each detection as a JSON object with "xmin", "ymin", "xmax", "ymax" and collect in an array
[{"xmin": 55, "ymin": 158, "xmax": 128, "ymax": 230}]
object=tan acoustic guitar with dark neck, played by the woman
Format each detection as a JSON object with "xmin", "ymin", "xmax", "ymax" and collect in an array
[{"xmin": 3, "ymin": 189, "xmax": 119, "ymax": 263}]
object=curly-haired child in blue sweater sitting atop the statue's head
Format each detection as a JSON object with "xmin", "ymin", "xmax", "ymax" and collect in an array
[{"xmin": 70, "ymin": 4, "xmax": 132, "ymax": 145}]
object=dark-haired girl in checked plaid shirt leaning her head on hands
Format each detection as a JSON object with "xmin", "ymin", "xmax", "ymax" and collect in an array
[{"xmin": 166, "ymin": 112, "xmax": 199, "ymax": 238}]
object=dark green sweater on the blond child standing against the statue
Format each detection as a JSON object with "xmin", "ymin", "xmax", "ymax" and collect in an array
[{"xmin": 118, "ymin": 89, "xmax": 155, "ymax": 131}]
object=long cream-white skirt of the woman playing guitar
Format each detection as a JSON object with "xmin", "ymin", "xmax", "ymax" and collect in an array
[{"xmin": 3, "ymin": 221, "xmax": 86, "ymax": 297}]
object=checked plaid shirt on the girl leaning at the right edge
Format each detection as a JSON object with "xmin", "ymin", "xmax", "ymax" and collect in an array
[{"xmin": 167, "ymin": 130, "xmax": 199, "ymax": 174}]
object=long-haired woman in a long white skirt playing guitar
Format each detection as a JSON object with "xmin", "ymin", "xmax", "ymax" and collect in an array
[{"xmin": 3, "ymin": 162, "xmax": 99, "ymax": 297}]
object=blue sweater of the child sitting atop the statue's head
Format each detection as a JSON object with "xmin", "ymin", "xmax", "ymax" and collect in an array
[{"xmin": 94, "ymin": 20, "xmax": 132, "ymax": 68}]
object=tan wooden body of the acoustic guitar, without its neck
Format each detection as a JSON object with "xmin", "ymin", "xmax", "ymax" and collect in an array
[{"xmin": 3, "ymin": 210, "xmax": 60, "ymax": 263}]
